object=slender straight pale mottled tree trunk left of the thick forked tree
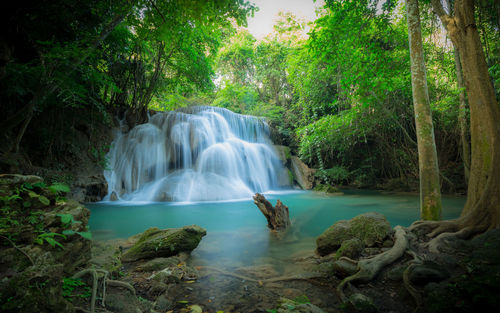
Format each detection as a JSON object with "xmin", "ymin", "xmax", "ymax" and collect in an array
[{"xmin": 406, "ymin": 0, "xmax": 441, "ymax": 220}]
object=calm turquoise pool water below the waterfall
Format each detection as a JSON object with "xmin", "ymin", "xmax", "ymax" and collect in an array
[{"xmin": 87, "ymin": 191, "xmax": 465, "ymax": 268}]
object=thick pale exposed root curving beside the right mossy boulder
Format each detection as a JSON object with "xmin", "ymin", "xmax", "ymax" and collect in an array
[{"xmin": 337, "ymin": 226, "xmax": 409, "ymax": 302}]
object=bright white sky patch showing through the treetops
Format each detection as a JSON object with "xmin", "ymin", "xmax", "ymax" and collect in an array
[{"xmin": 248, "ymin": 0, "xmax": 324, "ymax": 39}]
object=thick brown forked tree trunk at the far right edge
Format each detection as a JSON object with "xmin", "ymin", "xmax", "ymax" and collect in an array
[{"xmin": 432, "ymin": 0, "xmax": 500, "ymax": 231}]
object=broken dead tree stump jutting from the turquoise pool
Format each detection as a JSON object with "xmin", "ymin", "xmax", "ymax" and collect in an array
[{"xmin": 253, "ymin": 193, "xmax": 291, "ymax": 233}]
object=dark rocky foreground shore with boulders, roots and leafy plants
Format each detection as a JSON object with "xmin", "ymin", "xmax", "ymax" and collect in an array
[{"xmin": 0, "ymin": 175, "xmax": 500, "ymax": 313}]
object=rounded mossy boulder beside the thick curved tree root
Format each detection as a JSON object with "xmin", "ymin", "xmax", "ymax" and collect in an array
[{"xmin": 316, "ymin": 212, "xmax": 391, "ymax": 256}]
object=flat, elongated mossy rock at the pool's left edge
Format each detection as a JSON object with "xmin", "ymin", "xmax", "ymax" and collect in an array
[{"xmin": 122, "ymin": 225, "xmax": 207, "ymax": 262}]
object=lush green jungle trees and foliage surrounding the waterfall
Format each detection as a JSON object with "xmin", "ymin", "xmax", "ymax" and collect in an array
[{"xmin": 0, "ymin": 0, "xmax": 500, "ymax": 224}]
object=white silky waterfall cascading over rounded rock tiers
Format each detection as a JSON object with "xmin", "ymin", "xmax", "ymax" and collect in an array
[{"xmin": 104, "ymin": 106, "xmax": 286, "ymax": 201}]
